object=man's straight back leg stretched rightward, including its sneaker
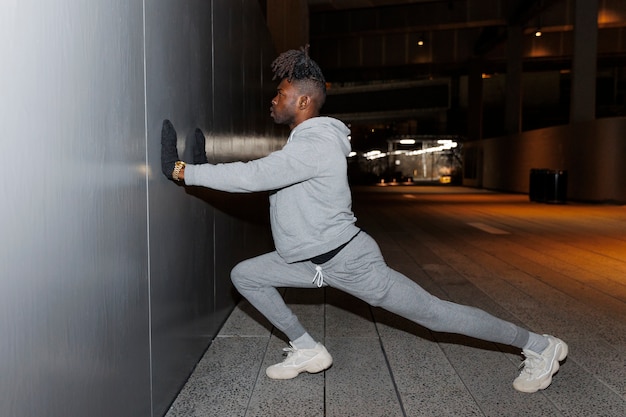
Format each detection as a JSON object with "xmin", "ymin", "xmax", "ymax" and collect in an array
[{"xmin": 323, "ymin": 233, "xmax": 567, "ymax": 392}]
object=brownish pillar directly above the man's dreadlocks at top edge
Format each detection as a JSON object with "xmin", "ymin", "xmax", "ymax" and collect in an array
[{"xmin": 267, "ymin": 0, "xmax": 309, "ymax": 54}]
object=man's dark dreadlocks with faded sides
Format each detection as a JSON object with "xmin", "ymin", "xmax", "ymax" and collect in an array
[{"xmin": 272, "ymin": 44, "xmax": 326, "ymax": 106}]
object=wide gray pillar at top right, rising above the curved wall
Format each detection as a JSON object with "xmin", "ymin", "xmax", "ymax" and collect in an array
[{"xmin": 570, "ymin": 0, "xmax": 598, "ymax": 123}]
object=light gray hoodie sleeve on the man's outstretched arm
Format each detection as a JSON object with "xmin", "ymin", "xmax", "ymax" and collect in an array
[{"xmin": 185, "ymin": 140, "xmax": 319, "ymax": 193}]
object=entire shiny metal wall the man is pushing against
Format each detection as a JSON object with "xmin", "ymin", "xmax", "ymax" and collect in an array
[{"xmin": 0, "ymin": 0, "xmax": 281, "ymax": 417}]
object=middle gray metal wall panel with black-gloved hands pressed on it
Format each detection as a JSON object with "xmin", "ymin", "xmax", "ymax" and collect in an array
[{"xmin": 146, "ymin": 0, "xmax": 214, "ymax": 416}]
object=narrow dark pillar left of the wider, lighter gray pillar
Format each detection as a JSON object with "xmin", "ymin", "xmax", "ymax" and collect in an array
[{"xmin": 504, "ymin": 25, "xmax": 523, "ymax": 134}]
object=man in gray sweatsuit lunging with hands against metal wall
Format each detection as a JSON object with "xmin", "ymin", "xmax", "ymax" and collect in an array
[{"xmin": 162, "ymin": 46, "xmax": 568, "ymax": 392}]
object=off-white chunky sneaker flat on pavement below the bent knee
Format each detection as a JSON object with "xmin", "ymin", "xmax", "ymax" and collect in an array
[{"xmin": 265, "ymin": 343, "xmax": 333, "ymax": 379}]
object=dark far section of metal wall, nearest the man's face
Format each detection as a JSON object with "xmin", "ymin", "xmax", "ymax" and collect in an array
[{"xmin": 211, "ymin": 2, "xmax": 273, "ymax": 319}]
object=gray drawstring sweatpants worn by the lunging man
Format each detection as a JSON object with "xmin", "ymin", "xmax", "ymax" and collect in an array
[{"xmin": 231, "ymin": 232, "xmax": 529, "ymax": 348}]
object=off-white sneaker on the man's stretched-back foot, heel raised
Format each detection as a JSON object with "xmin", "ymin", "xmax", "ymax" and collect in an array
[{"xmin": 513, "ymin": 334, "xmax": 568, "ymax": 392}]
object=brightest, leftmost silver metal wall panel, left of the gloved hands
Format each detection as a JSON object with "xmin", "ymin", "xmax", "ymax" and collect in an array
[{"xmin": 0, "ymin": 0, "xmax": 150, "ymax": 417}]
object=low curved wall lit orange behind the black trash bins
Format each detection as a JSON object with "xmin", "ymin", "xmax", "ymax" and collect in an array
[{"xmin": 464, "ymin": 117, "xmax": 626, "ymax": 204}]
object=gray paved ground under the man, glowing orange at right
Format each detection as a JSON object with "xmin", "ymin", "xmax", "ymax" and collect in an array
[{"xmin": 167, "ymin": 186, "xmax": 626, "ymax": 417}]
